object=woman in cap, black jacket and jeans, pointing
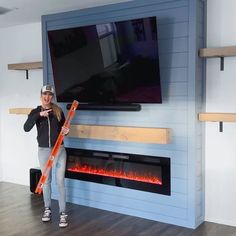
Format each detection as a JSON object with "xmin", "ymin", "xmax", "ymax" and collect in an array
[{"xmin": 24, "ymin": 85, "xmax": 69, "ymax": 227}]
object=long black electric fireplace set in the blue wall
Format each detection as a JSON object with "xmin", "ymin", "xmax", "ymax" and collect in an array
[{"xmin": 66, "ymin": 148, "xmax": 170, "ymax": 195}]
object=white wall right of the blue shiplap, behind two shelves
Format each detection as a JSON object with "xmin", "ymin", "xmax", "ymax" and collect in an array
[{"xmin": 205, "ymin": 0, "xmax": 236, "ymax": 226}]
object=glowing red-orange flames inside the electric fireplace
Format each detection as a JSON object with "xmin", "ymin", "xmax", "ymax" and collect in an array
[{"xmin": 67, "ymin": 165, "xmax": 162, "ymax": 185}]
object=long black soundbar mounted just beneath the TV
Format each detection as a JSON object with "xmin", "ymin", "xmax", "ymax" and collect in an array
[{"xmin": 66, "ymin": 103, "xmax": 141, "ymax": 111}]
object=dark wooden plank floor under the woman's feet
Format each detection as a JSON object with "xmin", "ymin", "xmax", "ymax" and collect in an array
[{"xmin": 0, "ymin": 182, "xmax": 236, "ymax": 236}]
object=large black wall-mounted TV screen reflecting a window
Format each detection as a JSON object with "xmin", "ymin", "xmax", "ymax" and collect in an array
[{"xmin": 48, "ymin": 17, "xmax": 162, "ymax": 105}]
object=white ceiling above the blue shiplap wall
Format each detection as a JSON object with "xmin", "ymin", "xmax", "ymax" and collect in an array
[{"xmin": 0, "ymin": 0, "xmax": 130, "ymax": 28}]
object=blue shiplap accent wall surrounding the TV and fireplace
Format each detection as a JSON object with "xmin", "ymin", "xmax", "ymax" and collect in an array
[{"xmin": 42, "ymin": 0, "xmax": 206, "ymax": 228}]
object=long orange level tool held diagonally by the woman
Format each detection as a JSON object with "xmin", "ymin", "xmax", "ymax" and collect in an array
[{"xmin": 35, "ymin": 100, "xmax": 79, "ymax": 194}]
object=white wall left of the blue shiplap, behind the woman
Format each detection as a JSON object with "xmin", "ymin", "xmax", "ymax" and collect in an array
[{"xmin": 0, "ymin": 23, "xmax": 43, "ymax": 185}]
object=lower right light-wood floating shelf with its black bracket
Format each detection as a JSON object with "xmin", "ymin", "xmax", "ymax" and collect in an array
[{"xmin": 198, "ymin": 112, "xmax": 236, "ymax": 132}]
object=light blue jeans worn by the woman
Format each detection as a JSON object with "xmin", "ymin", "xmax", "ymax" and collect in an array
[{"xmin": 38, "ymin": 146, "xmax": 66, "ymax": 212}]
